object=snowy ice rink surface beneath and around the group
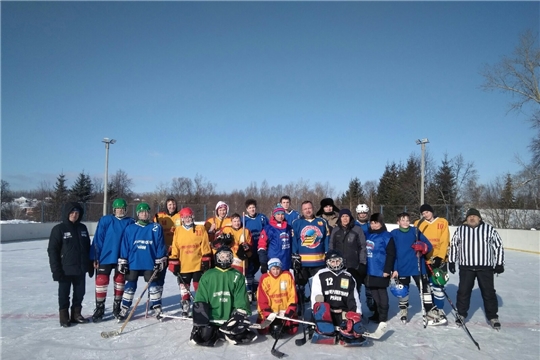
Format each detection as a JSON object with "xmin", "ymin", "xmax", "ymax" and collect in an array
[{"xmin": 0, "ymin": 240, "xmax": 540, "ymax": 360}]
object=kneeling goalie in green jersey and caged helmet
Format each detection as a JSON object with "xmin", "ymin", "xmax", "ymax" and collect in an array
[{"xmin": 190, "ymin": 246, "xmax": 257, "ymax": 346}]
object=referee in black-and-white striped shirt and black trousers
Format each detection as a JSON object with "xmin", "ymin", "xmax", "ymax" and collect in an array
[{"xmin": 448, "ymin": 208, "xmax": 504, "ymax": 330}]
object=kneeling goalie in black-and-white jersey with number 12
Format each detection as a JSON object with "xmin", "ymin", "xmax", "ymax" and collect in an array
[{"xmin": 311, "ymin": 250, "xmax": 367, "ymax": 346}]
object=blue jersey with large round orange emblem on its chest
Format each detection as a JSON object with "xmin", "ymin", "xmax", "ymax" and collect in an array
[{"xmin": 292, "ymin": 217, "xmax": 330, "ymax": 267}]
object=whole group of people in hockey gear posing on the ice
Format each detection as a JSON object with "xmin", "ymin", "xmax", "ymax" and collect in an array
[{"xmin": 49, "ymin": 196, "xmax": 504, "ymax": 350}]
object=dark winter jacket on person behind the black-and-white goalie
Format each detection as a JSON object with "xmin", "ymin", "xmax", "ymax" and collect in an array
[{"xmin": 329, "ymin": 219, "xmax": 367, "ymax": 269}]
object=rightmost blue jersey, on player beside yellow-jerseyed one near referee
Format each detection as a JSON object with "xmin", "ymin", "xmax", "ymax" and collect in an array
[{"xmin": 391, "ymin": 226, "xmax": 433, "ymax": 276}]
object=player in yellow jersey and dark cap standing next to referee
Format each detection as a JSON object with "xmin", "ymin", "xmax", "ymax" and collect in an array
[{"xmin": 414, "ymin": 204, "xmax": 450, "ymax": 323}]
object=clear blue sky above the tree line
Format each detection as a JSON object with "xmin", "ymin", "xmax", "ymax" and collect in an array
[{"xmin": 1, "ymin": 1, "xmax": 540, "ymax": 192}]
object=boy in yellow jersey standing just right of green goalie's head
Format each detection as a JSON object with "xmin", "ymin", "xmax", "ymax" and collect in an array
[{"xmin": 219, "ymin": 213, "xmax": 253, "ymax": 276}]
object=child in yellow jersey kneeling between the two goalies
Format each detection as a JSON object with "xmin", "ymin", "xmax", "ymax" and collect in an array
[{"xmin": 257, "ymin": 258, "xmax": 298, "ymax": 339}]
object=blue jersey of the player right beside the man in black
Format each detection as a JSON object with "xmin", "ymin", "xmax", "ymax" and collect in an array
[{"xmin": 90, "ymin": 215, "xmax": 135, "ymax": 265}]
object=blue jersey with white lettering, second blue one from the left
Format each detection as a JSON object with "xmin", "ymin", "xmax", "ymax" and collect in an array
[{"xmin": 120, "ymin": 223, "xmax": 167, "ymax": 270}]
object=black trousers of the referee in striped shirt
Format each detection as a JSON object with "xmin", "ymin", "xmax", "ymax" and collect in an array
[{"xmin": 456, "ymin": 266, "xmax": 499, "ymax": 320}]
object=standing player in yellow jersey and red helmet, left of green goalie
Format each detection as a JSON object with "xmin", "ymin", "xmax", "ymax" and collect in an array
[{"xmin": 169, "ymin": 208, "xmax": 212, "ymax": 316}]
